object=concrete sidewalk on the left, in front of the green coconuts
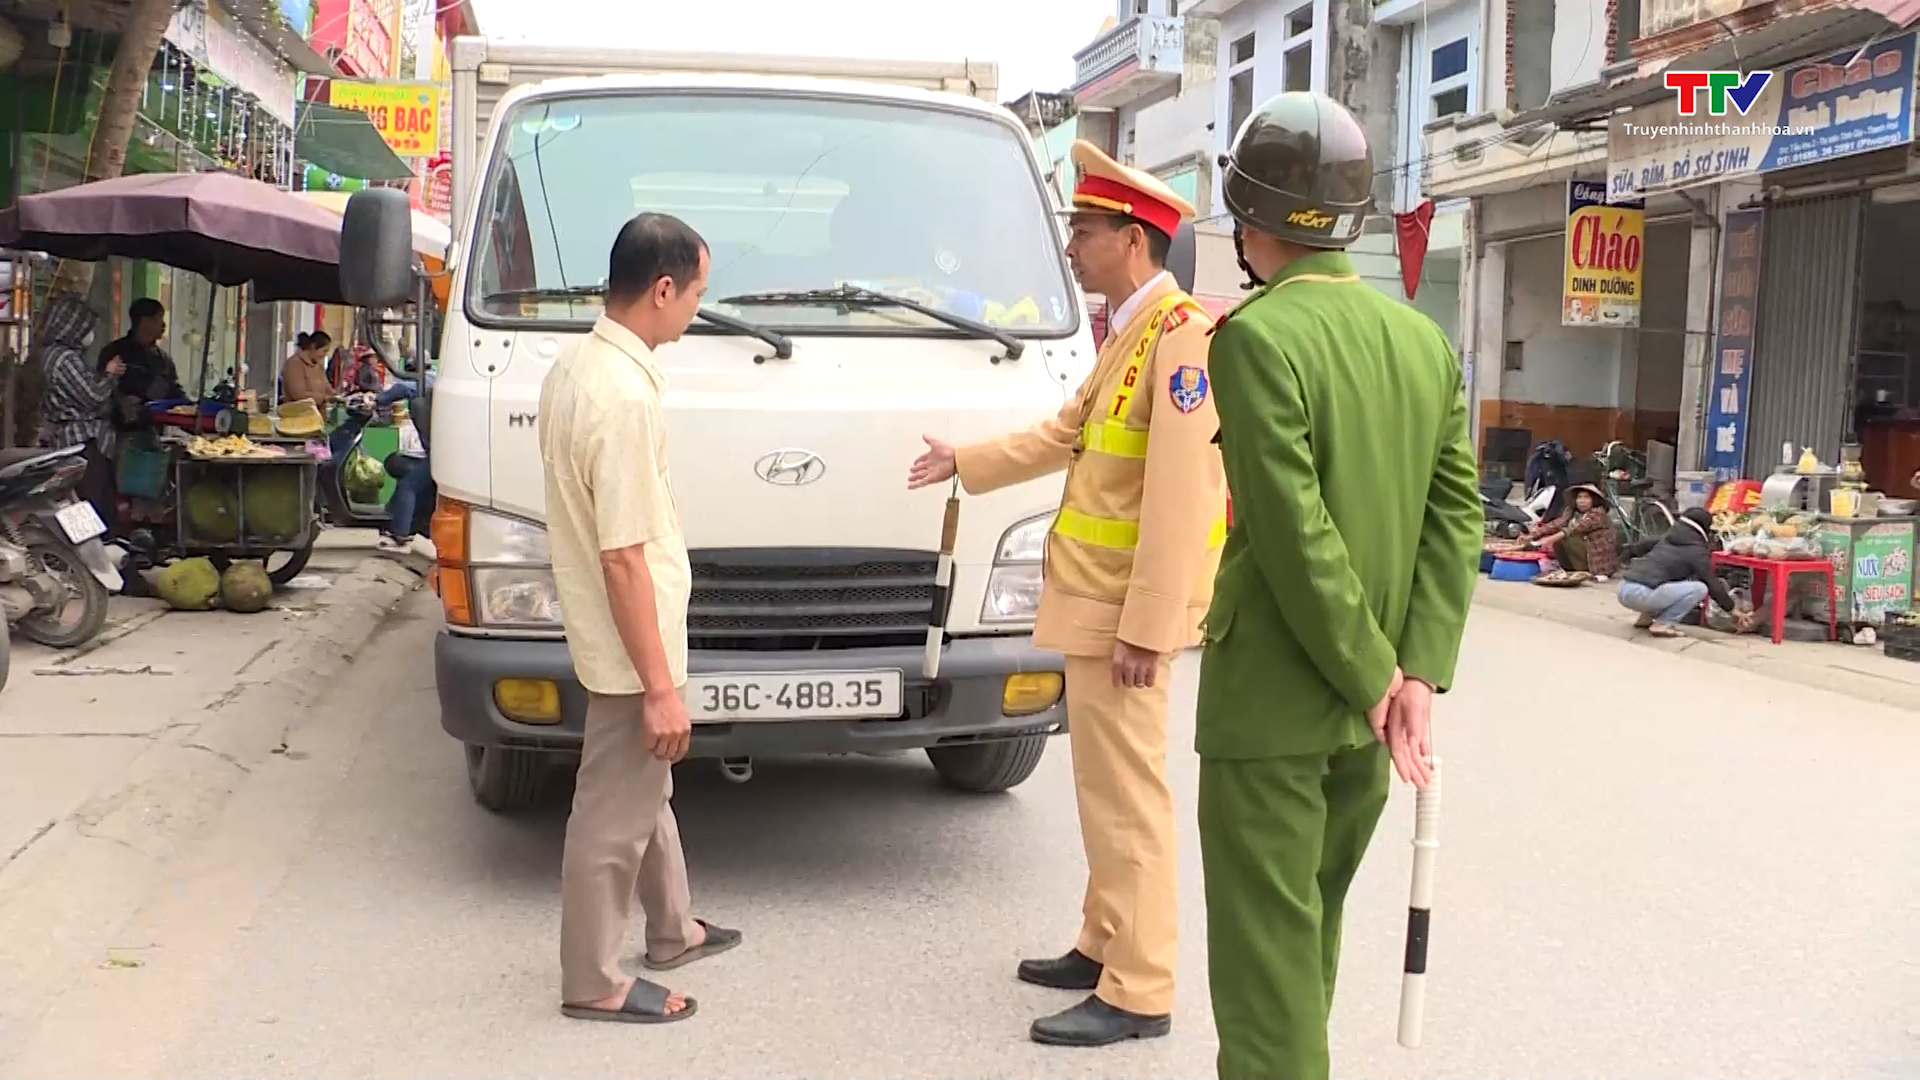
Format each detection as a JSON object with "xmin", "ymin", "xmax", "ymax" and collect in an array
[{"xmin": 0, "ymin": 530, "xmax": 426, "ymax": 1043}]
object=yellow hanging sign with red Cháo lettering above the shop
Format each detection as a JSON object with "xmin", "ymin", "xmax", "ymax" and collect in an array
[{"xmin": 1561, "ymin": 181, "xmax": 1647, "ymax": 329}]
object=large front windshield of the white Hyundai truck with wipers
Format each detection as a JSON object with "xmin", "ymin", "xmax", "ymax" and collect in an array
[{"xmin": 468, "ymin": 92, "xmax": 1077, "ymax": 336}]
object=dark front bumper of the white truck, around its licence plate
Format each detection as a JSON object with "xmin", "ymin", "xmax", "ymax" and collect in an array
[{"xmin": 434, "ymin": 630, "xmax": 1068, "ymax": 757}]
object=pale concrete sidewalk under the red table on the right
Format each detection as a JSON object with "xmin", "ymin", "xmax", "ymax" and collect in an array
[{"xmin": 1473, "ymin": 577, "xmax": 1920, "ymax": 709}]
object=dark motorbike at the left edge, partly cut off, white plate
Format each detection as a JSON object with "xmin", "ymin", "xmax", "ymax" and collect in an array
[{"xmin": 0, "ymin": 446, "xmax": 121, "ymax": 657}]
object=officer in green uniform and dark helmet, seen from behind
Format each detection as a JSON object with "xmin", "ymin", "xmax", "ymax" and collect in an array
[{"xmin": 1196, "ymin": 92, "xmax": 1482, "ymax": 1080}]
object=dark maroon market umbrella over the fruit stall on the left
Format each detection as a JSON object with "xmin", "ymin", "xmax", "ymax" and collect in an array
[{"xmin": 0, "ymin": 173, "xmax": 346, "ymax": 304}]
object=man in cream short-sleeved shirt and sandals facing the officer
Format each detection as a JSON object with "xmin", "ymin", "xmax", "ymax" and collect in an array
[{"xmin": 540, "ymin": 213, "xmax": 741, "ymax": 1024}]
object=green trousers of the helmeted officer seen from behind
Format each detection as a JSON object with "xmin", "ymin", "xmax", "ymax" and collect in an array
[{"xmin": 1200, "ymin": 744, "xmax": 1390, "ymax": 1080}]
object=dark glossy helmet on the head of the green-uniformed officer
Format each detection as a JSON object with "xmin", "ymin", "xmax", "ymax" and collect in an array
[{"xmin": 1219, "ymin": 90, "xmax": 1373, "ymax": 248}]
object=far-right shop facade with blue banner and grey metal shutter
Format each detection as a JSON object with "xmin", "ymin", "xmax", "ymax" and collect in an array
[{"xmin": 1509, "ymin": 0, "xmax": 1920, "ymax": 484}]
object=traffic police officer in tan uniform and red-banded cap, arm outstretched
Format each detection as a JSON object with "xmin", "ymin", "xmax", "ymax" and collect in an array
[{"xmin": 910, "ymin": 142, "xmax": 1225, "ymax": 1045}]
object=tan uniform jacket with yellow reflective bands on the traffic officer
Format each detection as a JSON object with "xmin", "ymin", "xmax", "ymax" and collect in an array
[{"xmin": 958, "ymin": 277, "xmax": 1227, "ymax": 655}]
